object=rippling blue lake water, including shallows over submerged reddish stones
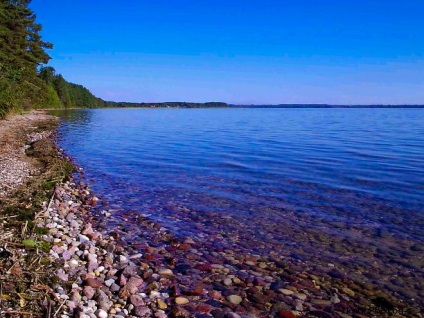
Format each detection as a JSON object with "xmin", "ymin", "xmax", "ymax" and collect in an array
[{"xmin": 56, "ymin": 109, "xmax": 424, "ymax": 306}]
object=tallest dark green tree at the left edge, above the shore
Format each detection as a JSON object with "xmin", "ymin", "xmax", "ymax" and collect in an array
[{"xmin": 0, "ymin": 0, "xmax": 53, "ymax": 118}]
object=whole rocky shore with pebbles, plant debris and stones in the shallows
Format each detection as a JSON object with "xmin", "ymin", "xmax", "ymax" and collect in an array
[{"xmin": 0, "ymin": 114, "xmax": 421, "ymax": 318}]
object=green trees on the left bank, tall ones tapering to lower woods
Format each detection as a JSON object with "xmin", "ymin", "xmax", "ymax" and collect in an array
[{"xmin": 0, "ymin": 0, "xmax": 105, "ymax": 118}]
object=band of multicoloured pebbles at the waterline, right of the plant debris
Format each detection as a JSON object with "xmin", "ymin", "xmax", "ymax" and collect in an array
[{"xmin": 0, "ymin": 112, "xmax": 416, "ymax": 318}]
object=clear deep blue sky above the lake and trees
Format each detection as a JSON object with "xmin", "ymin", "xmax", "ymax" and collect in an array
[{"xmin": 30, "ymin": 0, "xmax": 424, "ymax": 104}]
